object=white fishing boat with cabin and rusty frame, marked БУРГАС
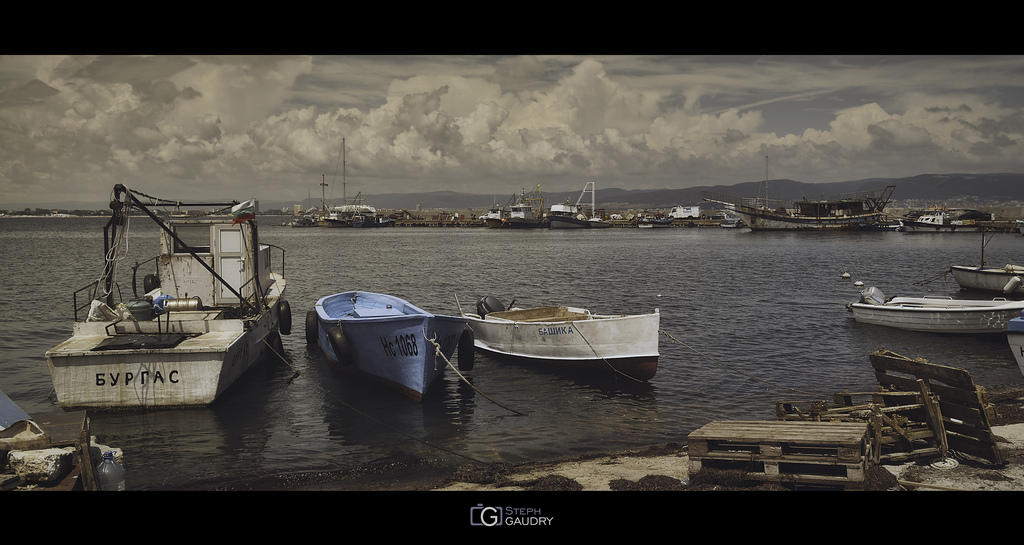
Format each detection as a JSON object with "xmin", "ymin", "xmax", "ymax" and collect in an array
[{"xmin": 46, "ymin": 184, "xmax": 291, "ymax": 409}]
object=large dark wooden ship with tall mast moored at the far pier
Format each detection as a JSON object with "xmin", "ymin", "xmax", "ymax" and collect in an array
[{"xmin": 701, "ymin": 157, "xmax": 896, "ymax": 230}]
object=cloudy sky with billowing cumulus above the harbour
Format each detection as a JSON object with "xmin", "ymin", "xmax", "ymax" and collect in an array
[{"xmin": 0, "ymin": 55, "xmax": 1024, "ymax": 208}]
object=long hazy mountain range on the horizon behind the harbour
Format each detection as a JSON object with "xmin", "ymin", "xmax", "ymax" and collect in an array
[{"xmin": 9, "ymin": 173, "xmax": 1024, "ymax": 211}]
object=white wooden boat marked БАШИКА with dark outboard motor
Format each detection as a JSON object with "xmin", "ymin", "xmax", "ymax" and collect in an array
[{"xmin": 465, "ymin": 297, "xmax": 660, "ymax": 380}]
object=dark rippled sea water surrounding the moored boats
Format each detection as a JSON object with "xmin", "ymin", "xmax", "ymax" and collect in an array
[{"xmin": 0, "ymin": 218, "xmax": 1024, "ymax": 490}]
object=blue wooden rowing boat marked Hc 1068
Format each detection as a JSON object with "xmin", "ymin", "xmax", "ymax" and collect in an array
[{"xmin": 306, "ymin": 291, "xmax": 473, "ymax": 401}]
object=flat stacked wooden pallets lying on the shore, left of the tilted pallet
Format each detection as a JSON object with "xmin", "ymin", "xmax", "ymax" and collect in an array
[{"xmin": 688, "ymin": 420, "xmax": 869, "ymax": 490}]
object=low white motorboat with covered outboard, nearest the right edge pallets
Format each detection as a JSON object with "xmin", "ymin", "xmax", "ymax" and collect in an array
[{"xmin": 847, "ymin": 287, "xmax": 1024, "ymax": 334}]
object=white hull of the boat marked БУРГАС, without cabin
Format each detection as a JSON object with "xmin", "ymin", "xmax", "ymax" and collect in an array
[{"xmin": 46, "ymin": 281, "xmax": 283, "ymax": 410}]
